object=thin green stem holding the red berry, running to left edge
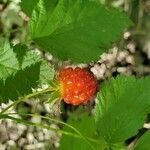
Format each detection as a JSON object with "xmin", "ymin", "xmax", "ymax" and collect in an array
[{"xmin": 0, "ymin": 88, "xmax": 54, "ymax": 115}]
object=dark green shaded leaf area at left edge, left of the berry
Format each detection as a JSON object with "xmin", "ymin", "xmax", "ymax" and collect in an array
[{"xmin": 0, "ymin": 63, "xmax": 41, "ymax": 102}]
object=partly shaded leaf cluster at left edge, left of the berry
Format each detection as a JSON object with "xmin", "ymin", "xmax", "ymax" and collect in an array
[{"xmin": 0, "ymin": 42, "xmax": 54, "ymax": 102}]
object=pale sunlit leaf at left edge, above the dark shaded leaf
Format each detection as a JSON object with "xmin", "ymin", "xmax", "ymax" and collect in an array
[{"xmin": 0, "ymin": 40, "xmax": 19, "ymax": 80}]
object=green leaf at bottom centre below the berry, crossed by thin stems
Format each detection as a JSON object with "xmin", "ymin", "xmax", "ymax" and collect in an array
[{"xmin": 59, "ymin": 112, "xmax": 106, "ymax": 150}]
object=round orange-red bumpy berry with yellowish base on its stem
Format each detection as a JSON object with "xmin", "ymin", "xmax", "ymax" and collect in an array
[{"xmin": 58, "ymin": 67, "xmax": 97, "ymax": 105}]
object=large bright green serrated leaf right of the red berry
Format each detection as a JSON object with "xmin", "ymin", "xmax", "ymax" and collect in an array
[{"xmin": 95, "ymin": 76, "xmax": 150, "ymax": 144}]
